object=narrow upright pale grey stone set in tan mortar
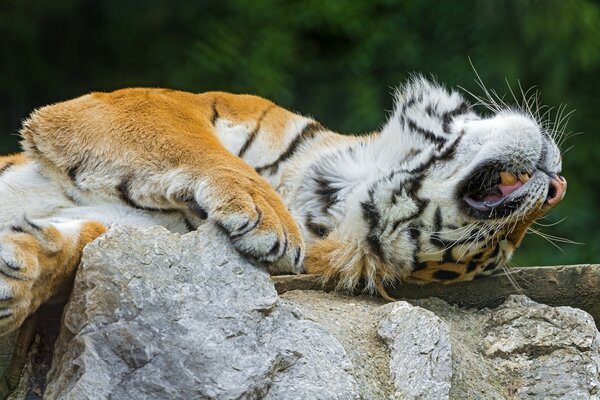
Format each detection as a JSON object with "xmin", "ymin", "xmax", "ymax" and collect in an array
[{"xmin": 378, "ymin": 301, "xmax": 452, "ymax": 400}]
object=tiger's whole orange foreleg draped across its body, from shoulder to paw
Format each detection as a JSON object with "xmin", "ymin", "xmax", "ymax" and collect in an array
[{"xmin": 21, "ymin": 89, "xmax": 304, "ymax": 273}]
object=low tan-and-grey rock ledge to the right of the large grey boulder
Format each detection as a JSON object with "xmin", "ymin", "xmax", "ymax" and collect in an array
[{"xmin": 281, "ymin": 290, "xmax": 600, "ymax": 400}]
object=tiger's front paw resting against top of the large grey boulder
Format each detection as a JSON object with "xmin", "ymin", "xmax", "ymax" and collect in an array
[{"xmin": 197, "ymin": 173, "xmax": 304, "ymax": 273}]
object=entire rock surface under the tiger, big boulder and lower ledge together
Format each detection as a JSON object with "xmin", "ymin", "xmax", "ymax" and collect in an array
[{"xmin": 12, "ymin": 226, "xmax": 600, "ymax": 399}]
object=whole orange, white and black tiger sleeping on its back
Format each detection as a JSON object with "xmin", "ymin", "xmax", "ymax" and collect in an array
[{"xmin": 0, "ymin": 76, "xmax": 567, "ymax": 334}]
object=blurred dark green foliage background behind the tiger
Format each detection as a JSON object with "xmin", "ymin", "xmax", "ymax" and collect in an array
[{"xmin": 0, "ymin": 0, "xmax": 600, "ymax": 265}]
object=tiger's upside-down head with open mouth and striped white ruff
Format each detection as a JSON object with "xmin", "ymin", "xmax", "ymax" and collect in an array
[{"xmin": 302, "ymin": 78, "xmax": 566, "ymax": 289}]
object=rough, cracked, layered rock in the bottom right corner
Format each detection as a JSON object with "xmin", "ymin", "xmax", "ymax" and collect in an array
[{"xmin": 482, "ymin": 296, "xmax": 600, "ymax": 399}]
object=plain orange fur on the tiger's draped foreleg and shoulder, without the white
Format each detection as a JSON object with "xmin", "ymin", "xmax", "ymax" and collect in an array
[{"xmin": 21, "ymin": 89, "xmax": 303, "ymax": 247}]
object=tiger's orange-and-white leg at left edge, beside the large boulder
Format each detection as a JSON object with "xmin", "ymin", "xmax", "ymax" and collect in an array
[{"xmin": 0, "ymin": 217, "xmax": 106, "ymax": 335}]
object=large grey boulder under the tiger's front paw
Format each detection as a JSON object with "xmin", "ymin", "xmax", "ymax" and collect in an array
[{"xmin": 44, "ymin": 226, "xmax": 358, "ymax": 400}]
